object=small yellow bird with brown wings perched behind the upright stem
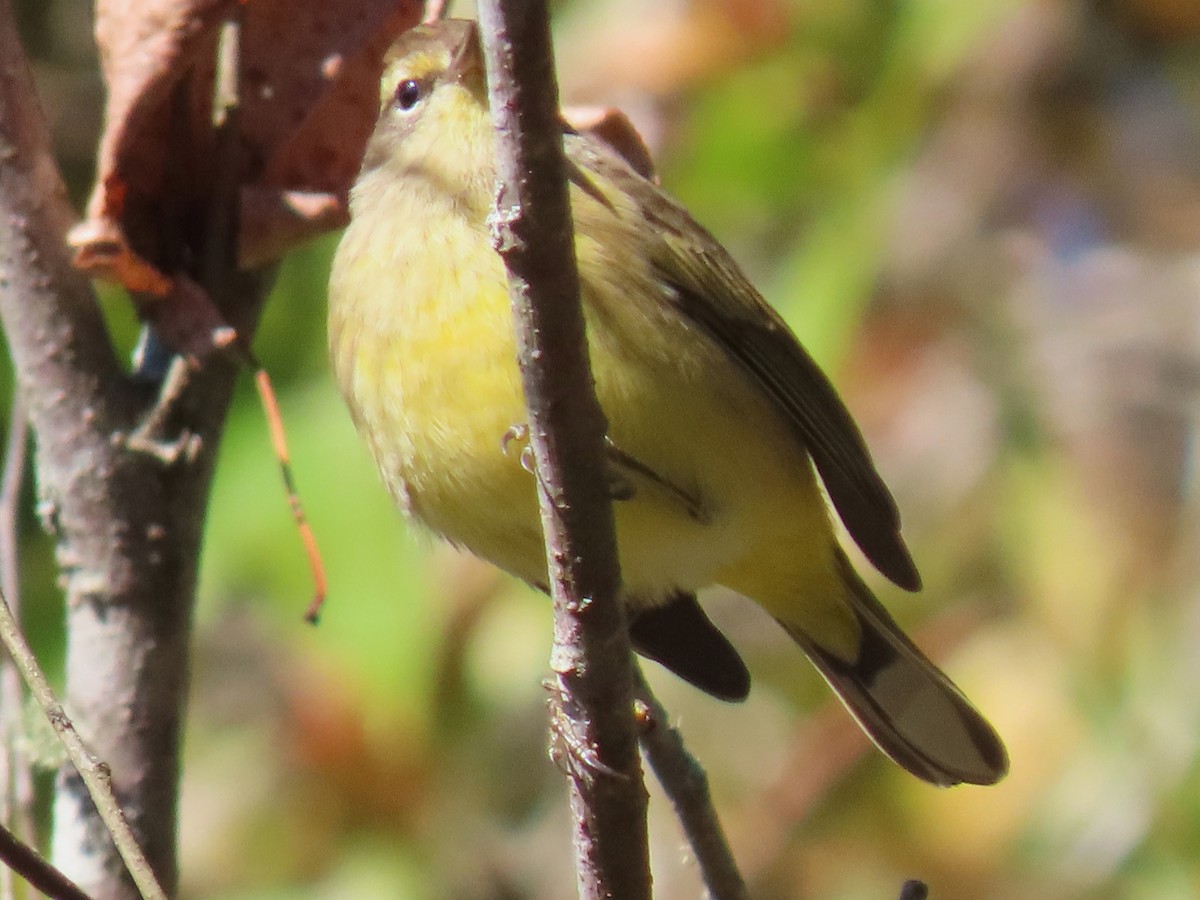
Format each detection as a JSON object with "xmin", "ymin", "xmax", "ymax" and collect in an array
[{"xmin": 329, "ymin": 20, "xmax": 1008, "ymax": 785}]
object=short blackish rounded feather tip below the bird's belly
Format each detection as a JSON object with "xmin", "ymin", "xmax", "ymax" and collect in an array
[{"xmin": 629, "ymin": 594, "xmax": 750, "ymax": 702}]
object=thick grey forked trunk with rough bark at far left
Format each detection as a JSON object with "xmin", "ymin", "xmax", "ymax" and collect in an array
[{"xmin": 0, "ymin": 0, "xmax": 260, "ymax": 900}]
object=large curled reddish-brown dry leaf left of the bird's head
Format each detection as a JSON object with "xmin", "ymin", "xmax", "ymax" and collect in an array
[{"xmin": 70, "ymin": 0, "xmax": 421, "ymax": 349}]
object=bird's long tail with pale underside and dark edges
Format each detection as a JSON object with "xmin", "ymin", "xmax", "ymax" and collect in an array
[{"xmin": 780, "ymin": 557, "xmax": 1008, "ymax": 786}]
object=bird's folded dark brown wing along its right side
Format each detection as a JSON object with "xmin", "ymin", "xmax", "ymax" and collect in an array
[{"xmin": 565, "ymin": 134, "xmax": 920, "ymax": 590}]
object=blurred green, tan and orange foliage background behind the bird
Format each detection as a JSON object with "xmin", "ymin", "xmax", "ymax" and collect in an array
[{"xmin": 6, "ymin": 0, "xmax": 1200, "ymax": 900}]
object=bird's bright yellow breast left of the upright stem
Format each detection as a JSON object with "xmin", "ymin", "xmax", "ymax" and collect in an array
[{"xmin": 329, "ymin": 168, "xmax": 549, "ymax": 575}]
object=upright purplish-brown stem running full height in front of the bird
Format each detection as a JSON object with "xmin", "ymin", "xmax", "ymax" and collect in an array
[{"xmin": 479, "ymin": 0, "xmax": 649, "ymax": 900}]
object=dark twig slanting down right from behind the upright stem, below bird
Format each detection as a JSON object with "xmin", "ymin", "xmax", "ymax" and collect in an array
[{"xmin": 636, "ymin": 668, "xmax": 748, "ymax": 900}]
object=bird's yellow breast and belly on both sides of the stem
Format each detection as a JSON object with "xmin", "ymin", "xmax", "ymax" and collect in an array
[{"xmin": 330, "ymin": 172, "xmax": 841, "ymax": 643}]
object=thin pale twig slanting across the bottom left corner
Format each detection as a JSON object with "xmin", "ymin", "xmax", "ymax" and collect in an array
[{"xmin": 0, "ymin": 588, "xmax": 167, "ymax": 900}]
